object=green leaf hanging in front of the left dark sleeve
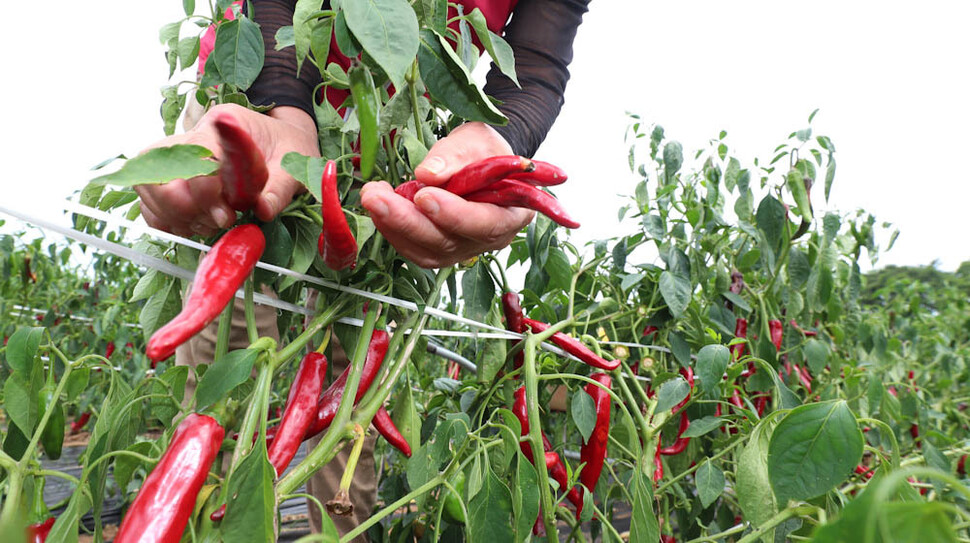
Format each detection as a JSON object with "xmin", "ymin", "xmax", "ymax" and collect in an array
[{"xmin": 206, "ymin": 17, "xmax": 265, "ymax": 90}]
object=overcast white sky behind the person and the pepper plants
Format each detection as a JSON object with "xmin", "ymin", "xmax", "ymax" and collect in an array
[{"xmin": 0, "ymin": 0, "xmax": 970, "ymax": 269}]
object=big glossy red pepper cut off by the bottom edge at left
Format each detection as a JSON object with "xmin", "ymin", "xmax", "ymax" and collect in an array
[{"xmin": 115, "ymin": 413, "xmax": 224, "ymax": 543}]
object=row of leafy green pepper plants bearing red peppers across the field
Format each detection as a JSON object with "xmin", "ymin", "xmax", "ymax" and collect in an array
[{"xmin": 0, "ymin": 0, "xmax": 970, "ymax": 542}]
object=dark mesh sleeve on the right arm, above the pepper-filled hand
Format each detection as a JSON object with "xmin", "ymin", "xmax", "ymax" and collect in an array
[{"xmin": 485, "ymin": 0, "xmax": 589, "ymax": 157}]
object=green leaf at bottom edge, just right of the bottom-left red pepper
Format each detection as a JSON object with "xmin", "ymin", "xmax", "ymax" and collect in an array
[{"xmin": 220, "ymin": 444, "xmax": 276, "ymax": 543}]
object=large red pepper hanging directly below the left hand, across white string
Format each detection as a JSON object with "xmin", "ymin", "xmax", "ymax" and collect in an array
[{"xmin": 145, "ymin": 224, "xmax": 266, "ymax": 367}]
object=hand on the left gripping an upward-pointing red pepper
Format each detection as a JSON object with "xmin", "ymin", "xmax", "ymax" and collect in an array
[{"xmin": 135, "ymin": 104, "xmax": 320, "ymax": 236}]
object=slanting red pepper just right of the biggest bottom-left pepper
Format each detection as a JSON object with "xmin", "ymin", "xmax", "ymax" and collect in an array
[{"xmin": 268, "ymin": 352, "xmax": 327, "ymax": 477}]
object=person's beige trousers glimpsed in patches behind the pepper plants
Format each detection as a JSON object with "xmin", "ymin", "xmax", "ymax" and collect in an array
[{"xmin": 175, "ymin": 288, "xmax": 377, "ymax": 543}]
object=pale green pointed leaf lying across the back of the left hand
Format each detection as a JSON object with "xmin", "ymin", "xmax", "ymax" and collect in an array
[{"xmin": 91, "ymin": 145, "xmax": 219, "ymax": 187}]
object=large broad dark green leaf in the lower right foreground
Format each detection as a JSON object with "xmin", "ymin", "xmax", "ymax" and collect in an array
[{"xmin": 768, "ymin": 401, "xmax": 864, "ymax": 503}]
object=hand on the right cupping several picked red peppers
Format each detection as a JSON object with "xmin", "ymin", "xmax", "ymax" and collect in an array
[{"xmin": 360, "ymin": 123, "xmax": 535, "ymax": 268}]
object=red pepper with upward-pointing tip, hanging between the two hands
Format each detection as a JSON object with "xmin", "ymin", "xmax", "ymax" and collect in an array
[{"xmin": 317, "ymin": 160, "xmax": 357, "ymax": 270}]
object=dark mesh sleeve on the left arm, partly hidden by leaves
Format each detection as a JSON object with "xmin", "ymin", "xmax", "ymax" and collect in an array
[{"xmin": 243, "ymin": 0, "xmax": 321, "ymax": 116}]
